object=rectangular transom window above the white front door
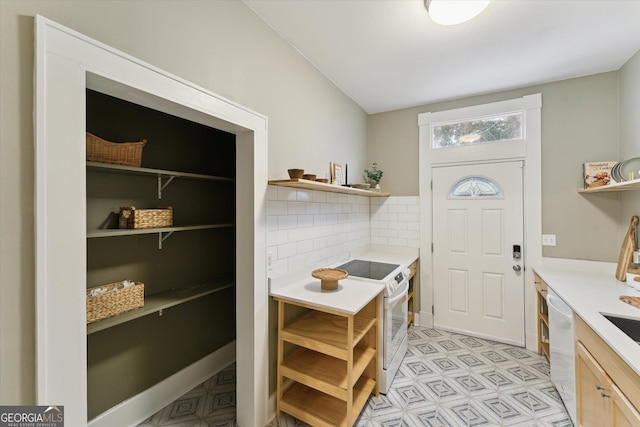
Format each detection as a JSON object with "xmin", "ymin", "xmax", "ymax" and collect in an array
[{"xmin": 431, "ymin": 111, "xmax": 524, "ymax": 148}]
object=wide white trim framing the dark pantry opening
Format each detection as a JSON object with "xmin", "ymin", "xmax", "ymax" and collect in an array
[{"xmin": 34, "ymin": 16, "xmax": 269, "ymax": 426}]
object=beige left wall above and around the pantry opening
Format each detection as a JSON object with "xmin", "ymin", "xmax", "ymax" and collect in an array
[{"xmin": 0, "ymin": 0, "xmax": 367, "ymax": 404}]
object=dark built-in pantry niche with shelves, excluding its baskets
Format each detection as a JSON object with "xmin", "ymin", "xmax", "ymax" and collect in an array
[{"xmin": 85, "ymin": 90, "xmax": 236, "ymax": 419}]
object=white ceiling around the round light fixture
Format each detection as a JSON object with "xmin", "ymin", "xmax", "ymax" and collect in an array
[{"xmin": 244, "ymin": 0, "xmax": 640, "ymax": 114}]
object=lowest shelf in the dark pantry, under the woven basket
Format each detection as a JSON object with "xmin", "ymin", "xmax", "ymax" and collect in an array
[{"xmin": 87, "ymin": 281, "xmax": 235, "ymax": 335}]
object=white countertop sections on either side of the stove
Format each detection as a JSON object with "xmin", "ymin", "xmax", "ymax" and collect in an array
[{"xmin": 269, "ymin": 248, "xmax": 418, "ymax": 314}]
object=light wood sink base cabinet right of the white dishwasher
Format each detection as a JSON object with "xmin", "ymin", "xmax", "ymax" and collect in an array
[{"xmin": 576, "ymin": 316, "xmax": 640, "ymax": 427}]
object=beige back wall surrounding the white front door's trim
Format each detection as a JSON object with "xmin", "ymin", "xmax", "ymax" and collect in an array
[{"xmin": 368, "ymin": 72, "xmax": 624, "ymax": 261}]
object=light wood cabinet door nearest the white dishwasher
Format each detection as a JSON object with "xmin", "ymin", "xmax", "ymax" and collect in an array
[{"xmin": 576, "ymin": 342, "xmax": 611, "ymax": 427}]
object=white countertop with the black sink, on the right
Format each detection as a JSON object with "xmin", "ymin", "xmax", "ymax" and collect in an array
[{"xmin": 534, "ymin": 267, "xmax": 640, "ymax": 375}]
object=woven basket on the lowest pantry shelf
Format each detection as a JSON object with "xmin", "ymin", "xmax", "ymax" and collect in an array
[{"xmin": 87, "ymin": 282, "xmax": 144, "ymax": 323}]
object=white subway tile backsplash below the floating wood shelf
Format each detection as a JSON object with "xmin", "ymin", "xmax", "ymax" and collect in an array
[{"xmin": 267, "ymin": 185, "xmax": 419, "ymax": 277}]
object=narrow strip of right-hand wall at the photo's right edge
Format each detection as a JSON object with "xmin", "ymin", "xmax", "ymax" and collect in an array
[{"xmin": 618, "ymin": 50, "xmax": 640, "ymax": 234}]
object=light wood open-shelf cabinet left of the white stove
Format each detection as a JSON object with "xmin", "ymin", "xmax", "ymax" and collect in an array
[{"xmin": 275, "ymin": 295, "xmax": 381, "ymax": 427}]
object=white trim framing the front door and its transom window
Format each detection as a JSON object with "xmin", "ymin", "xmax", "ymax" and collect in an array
[{"xmin": 418, "ymin": 93, "xmax": 542, "ymax": 350}]
